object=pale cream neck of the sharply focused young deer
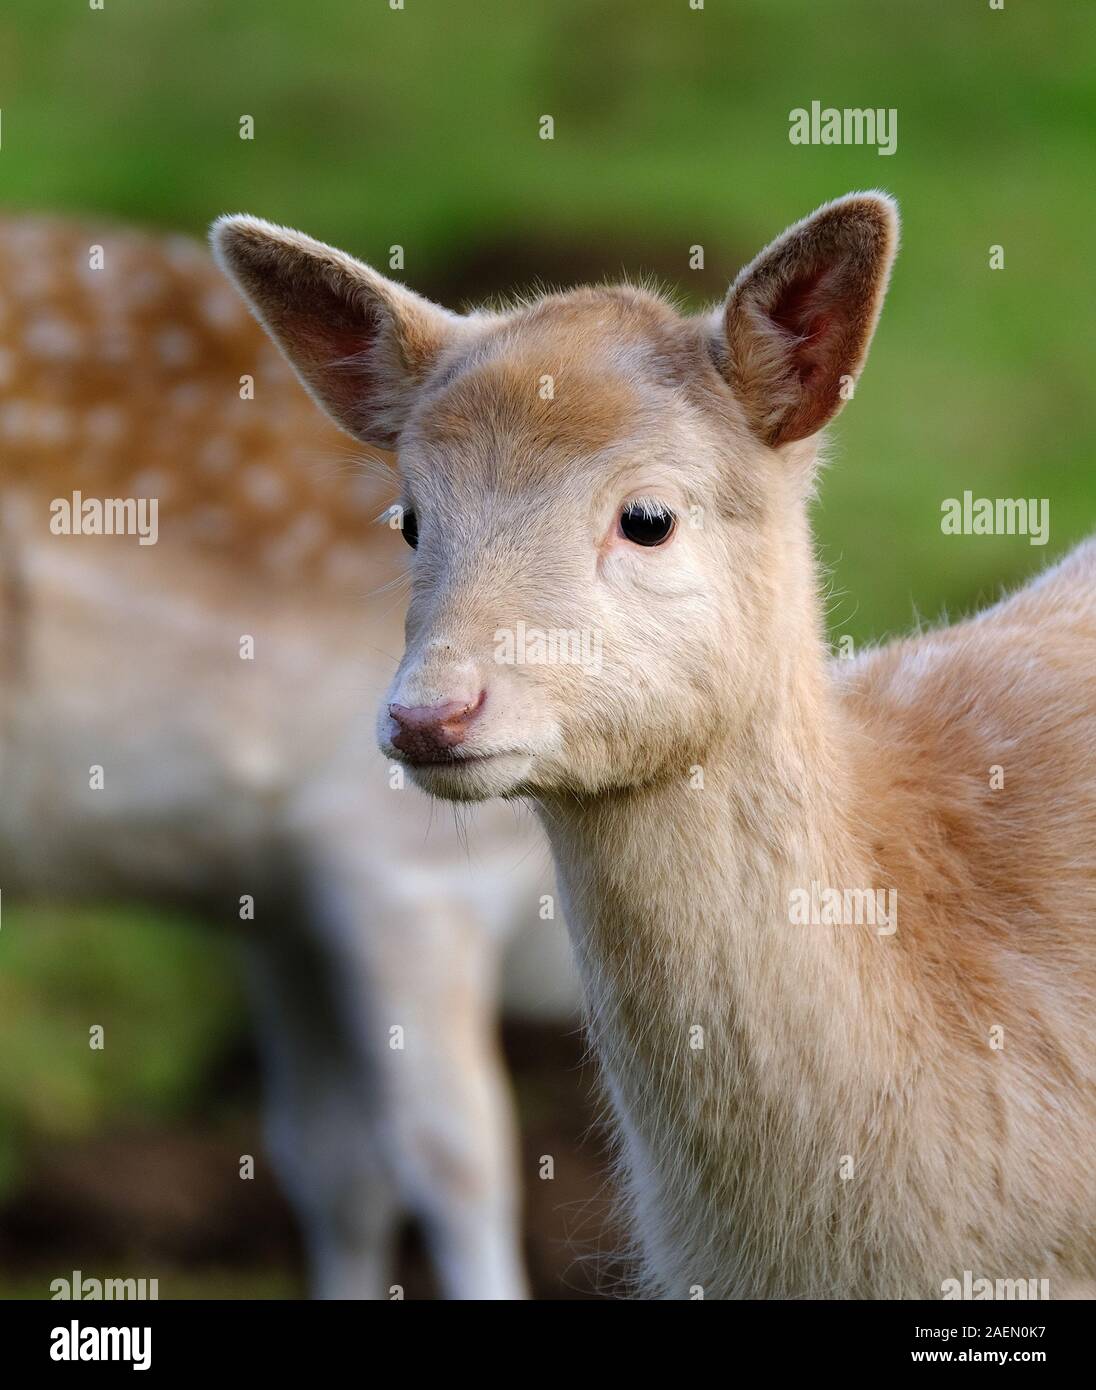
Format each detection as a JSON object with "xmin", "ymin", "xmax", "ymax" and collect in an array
[{"xmin": 542, "ymin": 542, "xmax": 901, "ymax": 1295}]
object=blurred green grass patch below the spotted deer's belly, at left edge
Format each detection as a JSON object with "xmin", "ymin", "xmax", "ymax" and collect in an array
[{"xmin": 0, "ymin": 904, "xmax": 245, "ymax": 1200}]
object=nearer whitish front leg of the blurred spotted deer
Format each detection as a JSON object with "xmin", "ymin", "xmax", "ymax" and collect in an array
[{"xmin": 297, "ymin": 838, "xmax": 527, "ymax": 1298}]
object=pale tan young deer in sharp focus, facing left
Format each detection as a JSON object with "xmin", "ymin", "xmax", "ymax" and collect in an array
[{"xmin": 214, "ymin": 193, "xmax": 1096, "ymax": 1298}]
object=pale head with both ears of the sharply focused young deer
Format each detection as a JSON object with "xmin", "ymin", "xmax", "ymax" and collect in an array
[{"xmin": 213, "ymin": 193, "xmax": 897, "ymax": 799}]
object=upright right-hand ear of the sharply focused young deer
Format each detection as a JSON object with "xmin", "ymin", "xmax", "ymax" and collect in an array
[{"xmin": 720, "ymin": 193, "xmax": 898, "ymax": 448}]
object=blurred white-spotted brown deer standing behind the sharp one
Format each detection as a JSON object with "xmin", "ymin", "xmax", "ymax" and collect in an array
[{"xmin": 0, "ymin": 218, "xmax": 574, "ymax": 1298}]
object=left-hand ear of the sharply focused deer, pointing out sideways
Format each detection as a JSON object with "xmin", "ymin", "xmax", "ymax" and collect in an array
[{"xmin": 210, "ymin": 217, "xmax": 463, "ymax": 449}]
